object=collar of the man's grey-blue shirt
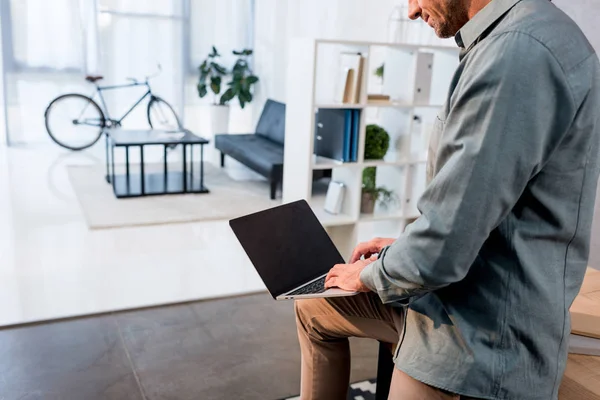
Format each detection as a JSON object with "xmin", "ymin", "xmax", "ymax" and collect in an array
[{"xmin": 455, "ymin": 0, "xmax": 521, "ymax": 50}]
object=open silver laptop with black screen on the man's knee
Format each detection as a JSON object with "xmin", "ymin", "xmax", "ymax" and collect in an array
[{"xmin": 229, "ymin": 200, "xmax": 357, "ymax": 300}]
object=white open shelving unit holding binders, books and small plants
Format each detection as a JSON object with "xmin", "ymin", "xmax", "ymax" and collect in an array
[{"xmin": 283, "ymin": 39, "xmax": 458, "ymax": 257}]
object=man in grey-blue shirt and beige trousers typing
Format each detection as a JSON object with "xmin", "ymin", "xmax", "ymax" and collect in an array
[{"xmin": 296, "ymin": 0, "xmax": 600, "ymax": 400}]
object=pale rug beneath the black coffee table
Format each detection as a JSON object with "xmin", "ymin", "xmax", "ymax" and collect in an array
[{"xmin": 67, "ymin": 163, "xmax": 281, "ymax": 229}]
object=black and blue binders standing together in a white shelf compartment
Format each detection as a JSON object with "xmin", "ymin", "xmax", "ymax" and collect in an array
[{"xmin": 314, "ymin": 109, "xmax": 360, "ymax": 162}]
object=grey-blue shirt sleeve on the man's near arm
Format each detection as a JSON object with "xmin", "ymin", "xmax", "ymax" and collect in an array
[{"xmin": 360, "ymin": 32, "xmax": 576, "ymax": 303}]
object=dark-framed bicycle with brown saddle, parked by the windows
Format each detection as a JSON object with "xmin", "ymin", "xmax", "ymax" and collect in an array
[{"xmin": 44, "ymin": 65, "xmax": 183, "ymax": 150}]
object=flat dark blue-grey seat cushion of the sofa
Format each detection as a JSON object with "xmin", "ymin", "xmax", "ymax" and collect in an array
[{"xmin": 215, "ymin": 134, "xmax": 283, "ymax": 177}]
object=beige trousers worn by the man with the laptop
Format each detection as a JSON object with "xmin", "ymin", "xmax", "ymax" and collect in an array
[{"xmin": 295, "ymin": 293, "xmax": 478, "ymax": 400}]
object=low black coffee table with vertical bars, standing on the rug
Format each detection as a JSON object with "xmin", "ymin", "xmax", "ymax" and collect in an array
[{"xmin": 105, "ymin": 129, "xmax": 209, "ymax": 198}]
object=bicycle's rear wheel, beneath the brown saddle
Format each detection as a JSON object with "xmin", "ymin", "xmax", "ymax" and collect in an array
[{"xmin": 44, "ymin": 93, "xmax": 106, "ymax": 150}]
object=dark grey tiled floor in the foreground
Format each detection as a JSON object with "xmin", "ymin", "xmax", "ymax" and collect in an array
[{"xmin": 0, "ymin": 294, "xmax": 378, "ymax": 400}]
